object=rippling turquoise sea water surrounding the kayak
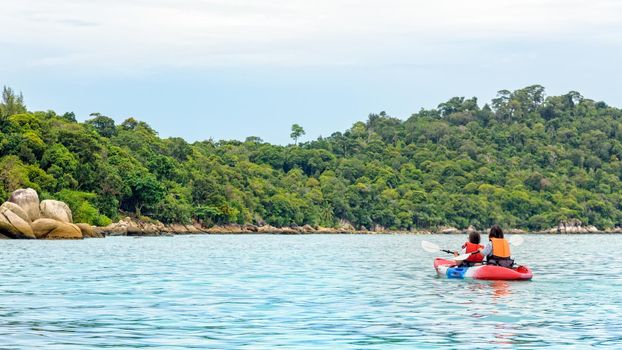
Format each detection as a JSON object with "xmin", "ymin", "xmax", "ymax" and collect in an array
[{"xmin": 0, "ymin": 235, "xmax": 622, "ymax": 349}]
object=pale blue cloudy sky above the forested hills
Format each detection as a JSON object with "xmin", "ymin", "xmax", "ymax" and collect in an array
[{"xmin": 0, "ymin": 0, "xmax": 622, "ymax": 144}]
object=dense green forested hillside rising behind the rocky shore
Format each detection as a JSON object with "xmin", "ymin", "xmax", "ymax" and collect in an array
[{"xmin": 0, "ymin": 85, "xmax": 622, "ymax": 229}]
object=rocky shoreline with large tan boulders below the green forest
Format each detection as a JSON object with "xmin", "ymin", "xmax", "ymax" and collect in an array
[{"xmin": 0, "ymin": 188, "xmax": 622, "ymax": 239}]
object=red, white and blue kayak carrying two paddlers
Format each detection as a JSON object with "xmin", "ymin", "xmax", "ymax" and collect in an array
[{"xmin": 434, "ymin": 258, "xmax": 533, "ymax": 281}]
